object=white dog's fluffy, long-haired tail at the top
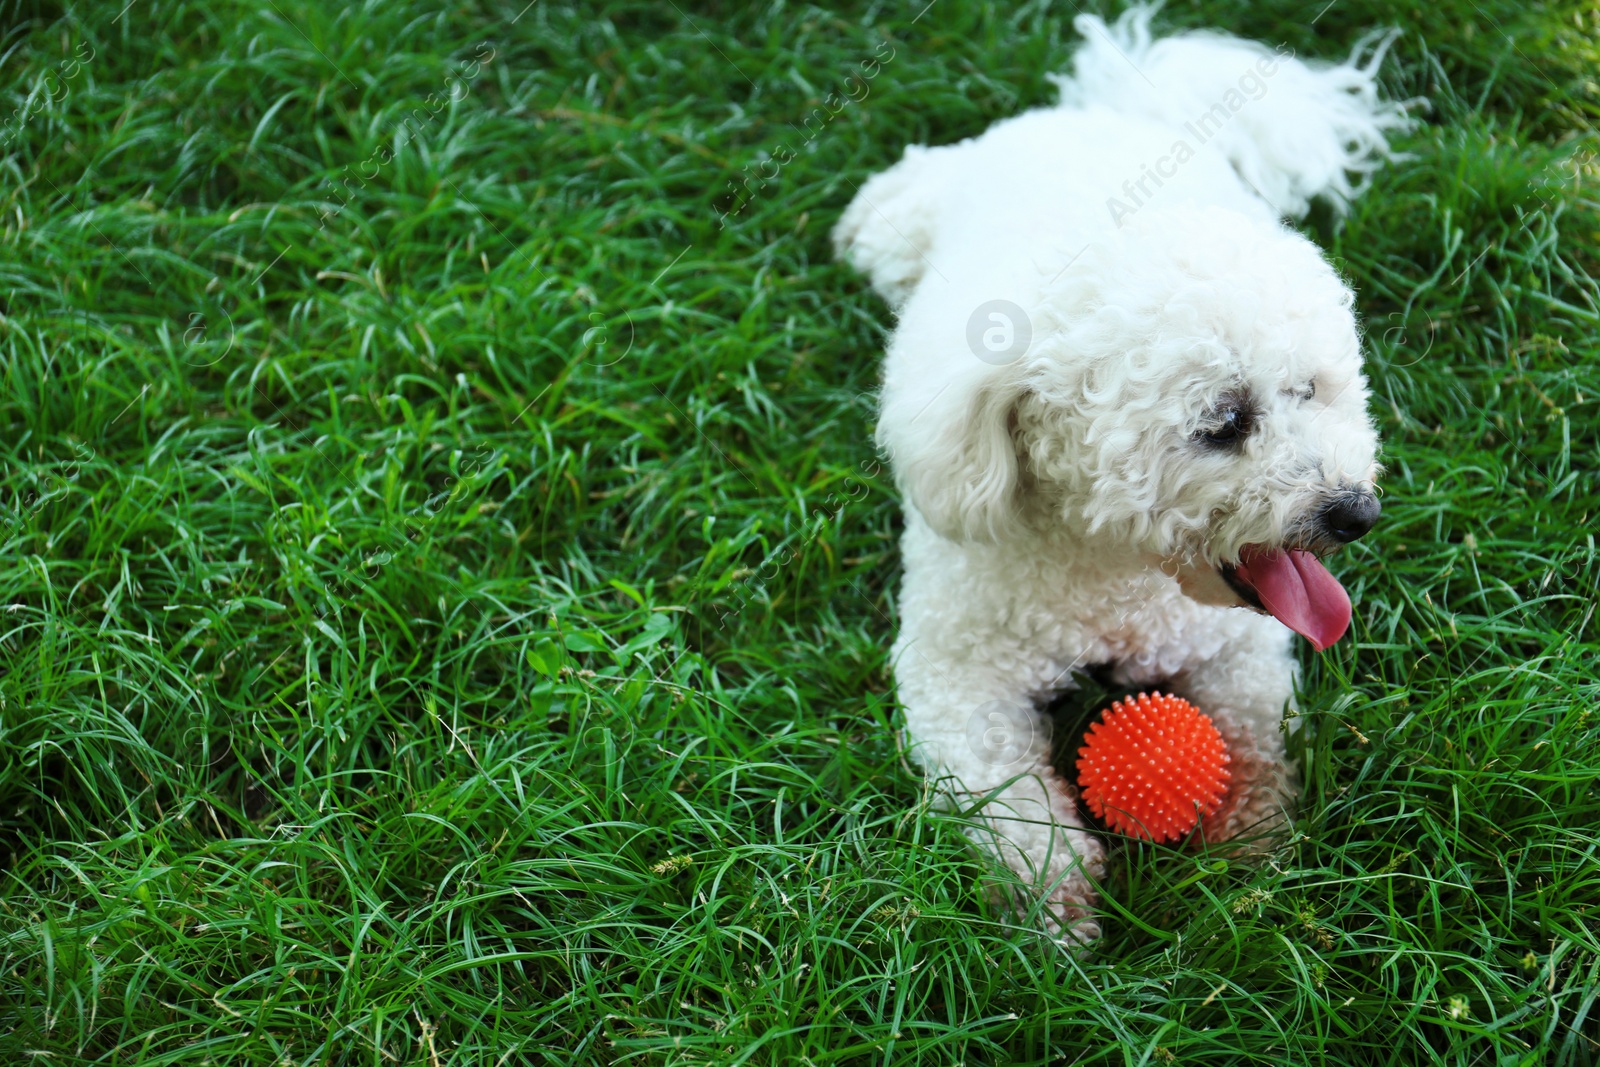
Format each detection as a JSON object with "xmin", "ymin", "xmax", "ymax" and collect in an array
[{"xmin": 1056, "ymin": 5, "xmax": 1411, "ymax": 218}]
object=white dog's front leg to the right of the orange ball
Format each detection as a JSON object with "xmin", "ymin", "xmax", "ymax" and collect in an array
[{"xmin": 1173, "ymin": 609, "xmax": 1299, "ymax": 851}]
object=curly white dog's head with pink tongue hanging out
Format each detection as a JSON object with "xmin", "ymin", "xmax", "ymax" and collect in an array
[{"xmin": 878, "ymin": 208, "xmax": 1379, "ymax": 648}]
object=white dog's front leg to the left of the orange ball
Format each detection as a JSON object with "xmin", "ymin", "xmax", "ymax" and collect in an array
[{"xmin": 894, "ymin": 646, "xmax": 1104, "ymax": 942}]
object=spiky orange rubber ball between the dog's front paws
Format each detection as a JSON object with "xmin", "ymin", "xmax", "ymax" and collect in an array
[{"xmin": 1078, "ymin": 693, "xmax": 1229, "ymax": 841}]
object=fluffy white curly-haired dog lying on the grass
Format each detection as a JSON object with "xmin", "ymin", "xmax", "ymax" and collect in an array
[{"xmin": 834, "ymin": 8, "xmax": 1406, "ymax": 939}]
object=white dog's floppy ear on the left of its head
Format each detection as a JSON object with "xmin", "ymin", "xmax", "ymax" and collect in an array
[{"xmin": 877, "ymin": 360, "xmax": 1026, "ymax": 542}]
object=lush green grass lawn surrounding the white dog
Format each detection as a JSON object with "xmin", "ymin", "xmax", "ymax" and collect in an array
[{"xmin": 0, "ymin": 0, "xmax": 1600, "ymax": 1067}]
